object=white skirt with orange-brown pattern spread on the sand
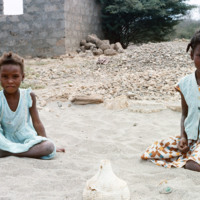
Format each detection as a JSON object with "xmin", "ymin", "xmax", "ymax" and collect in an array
[{"xmin": 141, "ymin": 136, "xmax": 200, "ymax": 168}]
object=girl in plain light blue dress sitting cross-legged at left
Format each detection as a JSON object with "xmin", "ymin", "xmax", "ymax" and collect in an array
[{"xmin": 0, "ymin": 52, "xmax": 64, "ymax": 159}]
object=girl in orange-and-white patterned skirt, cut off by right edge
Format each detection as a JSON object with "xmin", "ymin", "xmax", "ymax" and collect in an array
[{"xmin": 141, "ymin": 31, "xmax": 200, "ymax": 171}]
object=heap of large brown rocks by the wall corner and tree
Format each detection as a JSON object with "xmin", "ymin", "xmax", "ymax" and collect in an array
[{"xmin": 77, "ymin": 34, "xmax": 124, "ymax": 56}]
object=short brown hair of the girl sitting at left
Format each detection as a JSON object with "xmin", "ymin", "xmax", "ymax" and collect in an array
[{"xmin": 0, "ymin": 52, "xmax": 24, "ymax": 74}]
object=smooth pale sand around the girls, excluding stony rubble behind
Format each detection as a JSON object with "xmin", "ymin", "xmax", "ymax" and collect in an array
[{"xmin": 0, "ymin": 102, "xmax": 200, "ymax": 200}]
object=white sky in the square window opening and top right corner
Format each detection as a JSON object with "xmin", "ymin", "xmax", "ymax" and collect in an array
[{"xmin": 3, "ymin": 0, "xmax": 200, "ymax": 20}]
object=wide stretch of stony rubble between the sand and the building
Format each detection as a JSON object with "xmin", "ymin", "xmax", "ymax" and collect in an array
[{"xmin": 25, "ymin": 40, "xmax": 195, "ymax": 106}]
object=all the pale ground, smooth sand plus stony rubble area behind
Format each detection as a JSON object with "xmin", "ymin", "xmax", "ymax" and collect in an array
[{"xmin": 0, "ymin": 39, "xmax": 200, "ymax": 200}]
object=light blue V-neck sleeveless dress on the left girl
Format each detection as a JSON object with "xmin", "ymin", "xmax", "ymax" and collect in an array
[{"xmin": 0, "ymin": 88, "xmax": 56, "ymax": 159}]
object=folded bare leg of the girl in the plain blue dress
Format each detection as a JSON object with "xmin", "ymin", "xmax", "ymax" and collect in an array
[{"xmin": 0, "ymin": 141, "xmax": 54, "ymax": 158}]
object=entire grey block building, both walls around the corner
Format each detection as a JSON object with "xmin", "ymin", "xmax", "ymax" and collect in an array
[{"xmin": 0, "ymin": 0, "xmax": 100, "ymax": 57}]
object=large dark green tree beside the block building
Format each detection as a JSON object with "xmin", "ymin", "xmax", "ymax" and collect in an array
[{"xmin": 98, "ymin": 0, "xmax": 194, "ymax": 48}]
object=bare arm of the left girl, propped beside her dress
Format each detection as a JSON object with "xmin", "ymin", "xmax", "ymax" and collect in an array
[{"xmin": 29, "ymin": 92, "xmax": 47, "ymax": 137}]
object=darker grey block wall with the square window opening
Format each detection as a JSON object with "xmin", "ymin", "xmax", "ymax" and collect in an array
[{"xmin": 0, "ymin": 0, "xmax": 65, "ymax": 57}]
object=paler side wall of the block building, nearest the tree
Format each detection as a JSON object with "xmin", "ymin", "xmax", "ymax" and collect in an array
[{"xmin": 65, "ymin": 0, "xmax": 103, "ymax": 51}]
